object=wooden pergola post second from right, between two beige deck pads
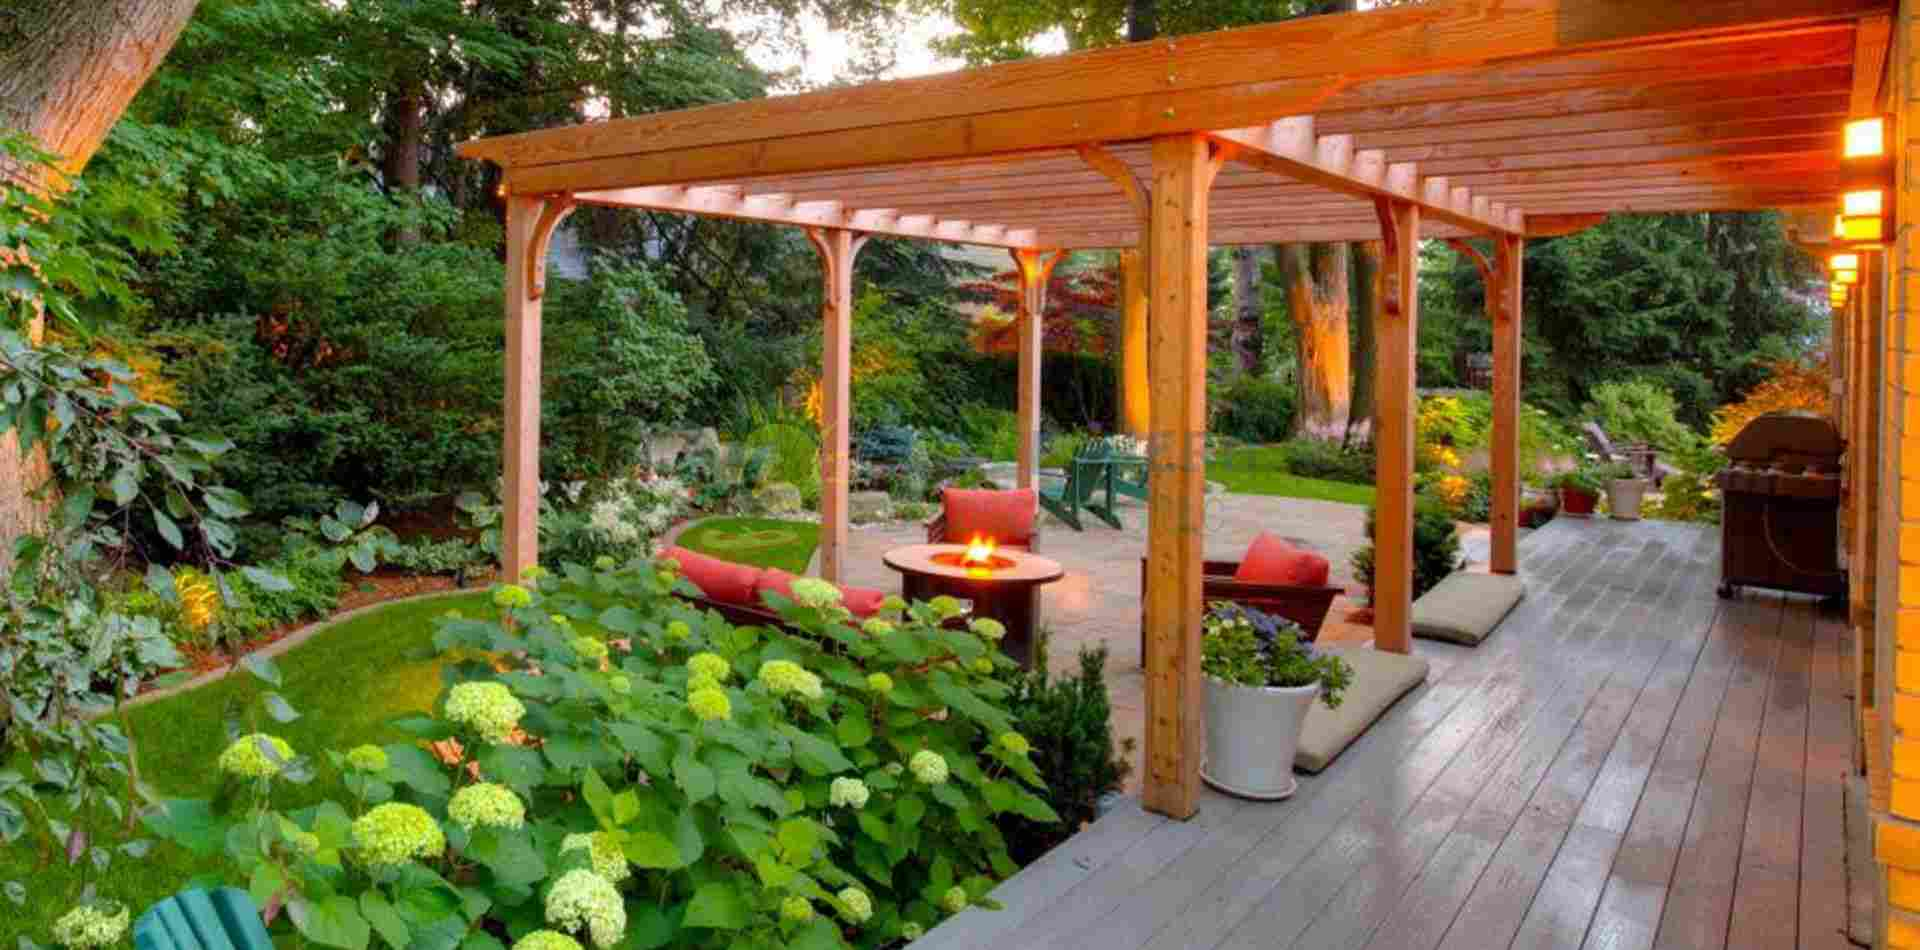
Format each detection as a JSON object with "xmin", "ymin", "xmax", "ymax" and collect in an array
[{"xmin": 1373, "ymin": 198, "xmax": 1421, "ymax": 653}]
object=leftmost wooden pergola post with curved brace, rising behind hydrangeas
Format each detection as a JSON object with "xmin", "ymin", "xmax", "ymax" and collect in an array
[{"xmin": 499, "ymin": 194, "xmax": 574, "ymax": 583}]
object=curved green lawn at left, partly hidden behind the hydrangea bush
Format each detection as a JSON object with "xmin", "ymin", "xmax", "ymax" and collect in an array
[{"xmin": 0, "ymin": 593, "xmax": 493, "ymax": 946}]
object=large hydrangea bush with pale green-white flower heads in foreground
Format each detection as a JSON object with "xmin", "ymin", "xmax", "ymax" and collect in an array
[{"xmin": 152, "ymin": 560, "xmax": 1058, "ymax": 950}]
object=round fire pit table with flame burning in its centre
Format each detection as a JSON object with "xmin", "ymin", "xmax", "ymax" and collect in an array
[{"xmin": 881, "ymin": 543, "xmax": 1066, "ymax": 668}]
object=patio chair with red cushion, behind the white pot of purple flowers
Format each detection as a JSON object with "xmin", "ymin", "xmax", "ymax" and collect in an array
[{"xmin": 1140, "ymin": 532, "xmax": 1346, "ymax": 666}]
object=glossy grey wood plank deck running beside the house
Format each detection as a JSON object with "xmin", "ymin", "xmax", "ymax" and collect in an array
[{"xmin": 914, "ymin": 518, "xmax": 1851, "ymax": 950}]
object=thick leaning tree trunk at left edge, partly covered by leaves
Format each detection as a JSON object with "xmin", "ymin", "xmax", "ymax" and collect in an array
[{"xmin": 0, "ymin": 0, "xmax": 198, "ymax": 570}]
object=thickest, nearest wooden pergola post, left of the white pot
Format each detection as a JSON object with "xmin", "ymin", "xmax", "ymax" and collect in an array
[{"xmin": 1140, "ymin": 134, "xmax": 1219, "ymax": 818}]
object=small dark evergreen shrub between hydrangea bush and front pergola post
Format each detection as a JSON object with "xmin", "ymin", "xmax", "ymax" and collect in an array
[{"xmin": 996, "ymin": 637, "xmax": 1133, "ymax": 864}]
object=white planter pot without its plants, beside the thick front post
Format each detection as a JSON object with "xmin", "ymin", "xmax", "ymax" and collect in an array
[{"xmin": 1200, "ymin": 677, "xmax": 1319, "ymax": 800}]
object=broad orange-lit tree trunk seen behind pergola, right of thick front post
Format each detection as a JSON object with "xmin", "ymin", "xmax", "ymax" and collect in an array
[{"xmin": 1273, "ymin": 244, "xmax": 1350, "ymax": 439}]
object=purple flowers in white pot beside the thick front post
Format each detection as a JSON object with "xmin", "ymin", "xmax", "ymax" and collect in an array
[{"xmin": 1200, "ymin": 603, "xmax": 1354, "ymax": 800}]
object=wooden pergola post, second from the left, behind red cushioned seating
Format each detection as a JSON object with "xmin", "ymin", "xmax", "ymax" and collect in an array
[{"xmin": 806, "ymin": 228, "xmax": 868, "ymax": 583}]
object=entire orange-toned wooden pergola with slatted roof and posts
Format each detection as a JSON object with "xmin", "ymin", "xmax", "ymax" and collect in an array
[{"xmin": 459, "ymin": 0, "xmax": 1893, "ymax": 816}]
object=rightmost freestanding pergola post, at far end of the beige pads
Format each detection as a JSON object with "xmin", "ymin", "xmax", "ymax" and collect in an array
[{"xmin": 1486, "ymin": 236, "xmax": 1526, "ymax": 574}]
